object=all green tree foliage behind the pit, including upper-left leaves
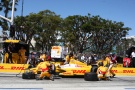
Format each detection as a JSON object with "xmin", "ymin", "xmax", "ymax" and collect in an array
[{"xmin": 0, "ymin": 0, "xmax": 130, "ymax": 55}]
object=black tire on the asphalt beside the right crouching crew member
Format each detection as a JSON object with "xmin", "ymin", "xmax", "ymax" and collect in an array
[{"xmin": 84, "ymin": 72, "xmax": 98, "ymax": 81}]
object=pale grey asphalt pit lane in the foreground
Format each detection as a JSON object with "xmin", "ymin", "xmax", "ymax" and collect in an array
[{"xmin": 0, "ymin": 73, "xmax": 135, "ymax": 90}]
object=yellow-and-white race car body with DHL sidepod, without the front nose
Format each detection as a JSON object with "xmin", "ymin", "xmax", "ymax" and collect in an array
[{"xmin": 56, "ymin": 59, "xmax": 98, "ymax": 76}]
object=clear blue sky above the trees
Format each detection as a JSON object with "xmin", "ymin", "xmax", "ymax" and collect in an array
[{"xmin": 0, "ymin": 0, "xmax": 135, "ymax": 36}]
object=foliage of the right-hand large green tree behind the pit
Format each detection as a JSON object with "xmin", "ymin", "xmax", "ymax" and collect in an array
[{"xmin": 63, "ymin": 14, "xmax": 130, "ymax": 54}]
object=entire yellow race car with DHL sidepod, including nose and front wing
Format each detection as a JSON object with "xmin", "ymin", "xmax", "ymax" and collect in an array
[{"xmin": 22, "ymin": 59, "xmax": 97, "ymax": 79}]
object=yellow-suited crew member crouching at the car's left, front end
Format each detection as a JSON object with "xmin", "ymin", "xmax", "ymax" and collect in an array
[{"xmin": 36, "ymin": 62, "xmax": 53, "ymax": 80}]
